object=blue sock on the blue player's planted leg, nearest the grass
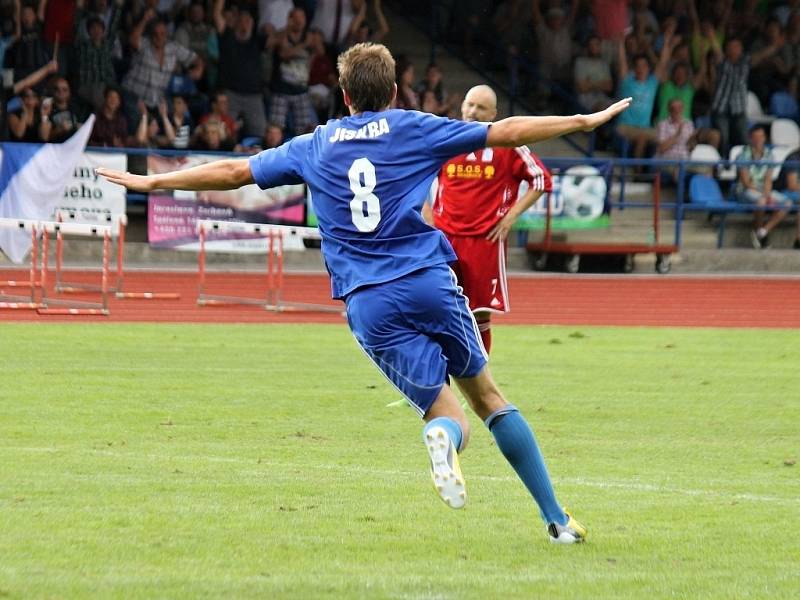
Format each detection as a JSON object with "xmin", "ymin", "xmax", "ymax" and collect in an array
[{"xmin": 486, "ymin": 404, "xmax": 567, "ymax": 525}]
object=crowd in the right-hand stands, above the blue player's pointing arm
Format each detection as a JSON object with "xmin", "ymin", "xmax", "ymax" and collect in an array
[{"xmin": 437, "ymin": 0, "xmax": 800, "ymax": 158}]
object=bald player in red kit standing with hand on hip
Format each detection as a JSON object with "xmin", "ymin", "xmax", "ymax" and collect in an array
[{"xmin": 426, "ymin": 85, "xmax": 552, "ymax": 352}]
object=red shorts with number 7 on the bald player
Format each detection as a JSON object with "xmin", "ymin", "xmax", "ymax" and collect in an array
[{"xmin": 447, "ymin": 235, "xmax": 511, "ymax": 313}]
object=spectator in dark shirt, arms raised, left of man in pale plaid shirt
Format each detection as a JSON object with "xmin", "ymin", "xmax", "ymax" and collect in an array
[{"xmin": 75, "ymin": 0, "xmax": 122, "ymax": 110}]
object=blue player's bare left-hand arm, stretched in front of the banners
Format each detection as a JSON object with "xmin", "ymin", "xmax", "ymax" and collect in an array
[{"xmin": 97, "ymin": 158, "xmax": 253, "ymax": 192}]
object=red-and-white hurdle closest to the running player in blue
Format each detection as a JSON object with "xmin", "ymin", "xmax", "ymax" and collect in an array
[{"xmin": 197, "ymin": 219, "xmax": 344, "ymax": 315}]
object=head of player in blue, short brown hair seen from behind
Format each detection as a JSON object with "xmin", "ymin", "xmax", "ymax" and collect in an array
[{"xmin": 338, "ymin": 43, "xmax": 394, "ymax": 112}]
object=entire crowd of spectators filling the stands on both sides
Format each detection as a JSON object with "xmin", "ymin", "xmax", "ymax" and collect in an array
[{"xmin": 0, "ymin": 0, "xmax": 800, "ymax": 247}]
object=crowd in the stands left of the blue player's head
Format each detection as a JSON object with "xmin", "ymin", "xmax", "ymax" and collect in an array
[{"xmin": 0, "ymin": 0, "xmax": 396, "ymax": 152}]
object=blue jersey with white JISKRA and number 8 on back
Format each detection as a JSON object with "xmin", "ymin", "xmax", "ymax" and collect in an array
[{"xmin": 250, "ymin": 110, "xmax": 488, "ymax": 298}]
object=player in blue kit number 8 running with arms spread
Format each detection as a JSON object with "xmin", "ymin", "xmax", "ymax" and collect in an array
[{"xmin": 97, "ymin": 44, "xmax": 630, "ymax": 543}]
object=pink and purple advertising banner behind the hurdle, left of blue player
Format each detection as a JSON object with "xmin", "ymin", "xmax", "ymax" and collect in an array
[{"xmin": 147, "ymin": 154, "xmax": 306, "ymax": 252}]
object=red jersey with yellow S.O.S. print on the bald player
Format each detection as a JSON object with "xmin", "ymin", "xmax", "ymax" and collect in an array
[{"xmin": 432, "ymin": 146, "xmax": 552, "ymax": 236}]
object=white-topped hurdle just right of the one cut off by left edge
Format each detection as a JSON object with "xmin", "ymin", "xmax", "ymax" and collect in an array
[{"xmin": 36, "ymin": 221, "xmax": 113, "ymax": 316}]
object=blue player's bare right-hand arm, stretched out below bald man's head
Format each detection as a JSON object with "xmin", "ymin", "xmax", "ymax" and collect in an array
[{"xmin": 486, "ymin": 98, "xmax": 631, "ymax": 146}]
